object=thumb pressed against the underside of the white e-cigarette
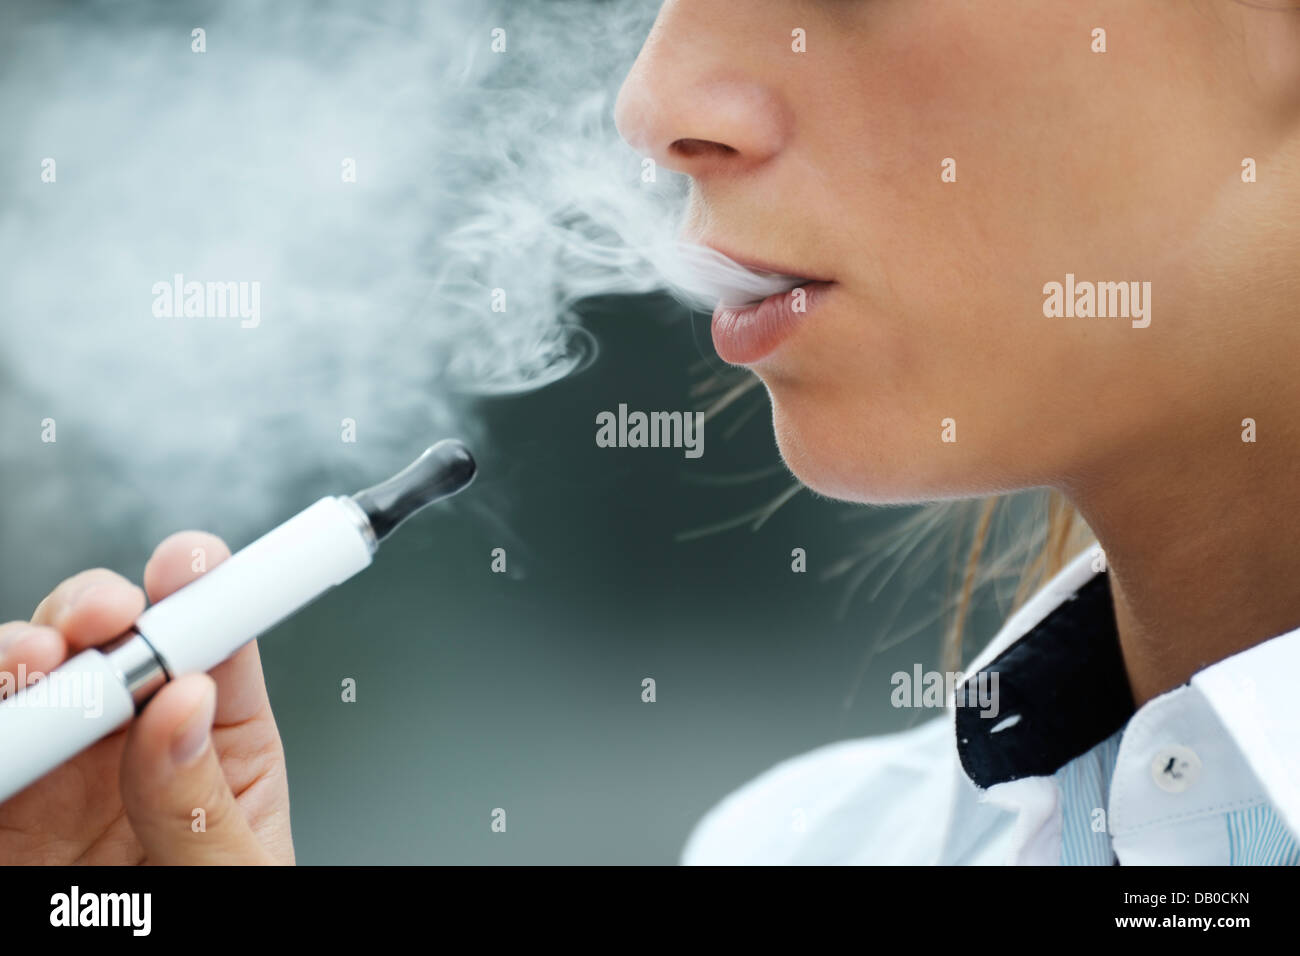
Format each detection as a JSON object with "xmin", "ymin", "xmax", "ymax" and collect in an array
[{"xmin": 122, "ymin": 674, "xmax": 274, "ymax": 866}]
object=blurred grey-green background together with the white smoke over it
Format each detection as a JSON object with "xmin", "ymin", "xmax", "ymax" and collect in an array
[{"xmin": 0, "ymin": 1, "xmax": 987, "ymax": 864}]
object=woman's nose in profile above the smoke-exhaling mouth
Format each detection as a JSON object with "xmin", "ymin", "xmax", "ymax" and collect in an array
[{"xmin": 614, "ymin": 0, "xmax": 792, "ymax": 179}]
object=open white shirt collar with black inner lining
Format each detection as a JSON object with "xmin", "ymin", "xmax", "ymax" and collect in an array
[{"xmin": 954, "ymin": 548, "xmax": 1300, "ymax": 832}]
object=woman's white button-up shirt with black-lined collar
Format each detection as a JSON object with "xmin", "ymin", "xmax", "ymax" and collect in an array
[{"xmin": 683, "ymin": 550, "xmax": 1300, "ymax": 865}]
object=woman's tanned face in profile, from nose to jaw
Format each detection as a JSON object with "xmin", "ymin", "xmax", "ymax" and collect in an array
[{"xmin": 618, "ymin": 0, "xmax": 1300, "ymax": 501}]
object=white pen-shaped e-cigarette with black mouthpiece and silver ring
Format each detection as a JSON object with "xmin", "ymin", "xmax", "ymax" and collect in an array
[{"xmin": 0, "ymin": 440, "xmax": 476, "ymax": 801}]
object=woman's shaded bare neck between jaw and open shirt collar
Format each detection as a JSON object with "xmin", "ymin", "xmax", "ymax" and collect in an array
[{"xmin": 1069, "ymin": 421, "xmax": 1300, "ymax": 706}]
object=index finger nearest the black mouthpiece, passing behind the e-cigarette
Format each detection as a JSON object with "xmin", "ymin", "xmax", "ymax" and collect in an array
[{"xmin": 144, "ymin": 531, "xmax": 270, "ymax": 726}]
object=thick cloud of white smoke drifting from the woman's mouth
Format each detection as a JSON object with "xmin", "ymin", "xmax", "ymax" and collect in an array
[{"xmin": 0, "ymin": 0, "xmax": 681, "ymax": 570}]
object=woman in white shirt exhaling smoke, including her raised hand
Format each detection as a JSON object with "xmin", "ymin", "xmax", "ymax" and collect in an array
[{"xmin": 0, "ymin": 0, "xmax": 1300, "ymax": 864}]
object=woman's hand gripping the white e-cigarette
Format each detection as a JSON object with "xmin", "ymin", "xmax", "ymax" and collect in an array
[{"xmin": 0, "ymin": 531, "xmax": 294, "ymax": 865}]
